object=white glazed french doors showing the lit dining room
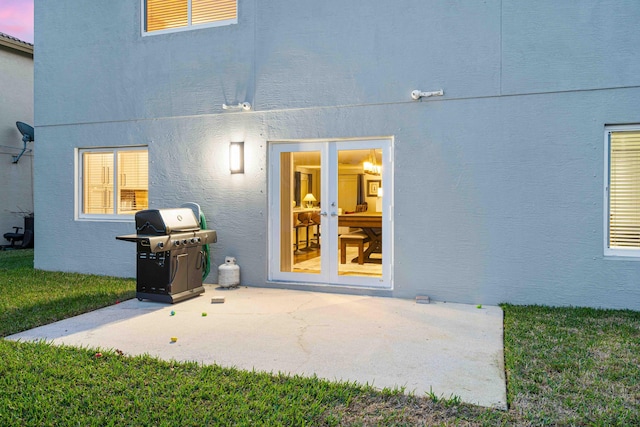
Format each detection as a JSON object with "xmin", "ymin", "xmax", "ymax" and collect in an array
[{"xmin": 269, "ymin": 139, "xmax": 393, "ymax": 289}]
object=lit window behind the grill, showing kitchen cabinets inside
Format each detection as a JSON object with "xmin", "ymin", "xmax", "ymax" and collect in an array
[{"xmin": 78, "ymin": 147, "xmax": 149, "ymax": 219}]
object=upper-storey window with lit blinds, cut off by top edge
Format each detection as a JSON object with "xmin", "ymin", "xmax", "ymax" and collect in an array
[{"xmin": 142, "ymin": 0, "xmax": 238, "ymax": 34}]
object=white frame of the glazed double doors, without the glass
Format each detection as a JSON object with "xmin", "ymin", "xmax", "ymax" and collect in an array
[{"xmin": 267, "ymin": 137, "xmax": 394, "ymax": 290}]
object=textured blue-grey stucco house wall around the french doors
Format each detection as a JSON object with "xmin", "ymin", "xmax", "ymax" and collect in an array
[{"xmin": 35, "ymin": 0, "xmax": 640, "ymax": 309}]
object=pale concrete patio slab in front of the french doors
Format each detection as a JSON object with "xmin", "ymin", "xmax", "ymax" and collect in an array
[{"xmin": 6, "ymin": 285, "xmax": 506, "ymax": 409}]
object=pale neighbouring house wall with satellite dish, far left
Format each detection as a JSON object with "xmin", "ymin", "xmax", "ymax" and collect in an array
[{"xmin": 0, "ymin": 34, "xmax": 33, "ymax": 245}]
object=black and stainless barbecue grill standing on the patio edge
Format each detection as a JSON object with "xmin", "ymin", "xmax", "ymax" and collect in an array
[{"xmin": 116, "ymin": 208, "xmax": 217, "ymax": 303}]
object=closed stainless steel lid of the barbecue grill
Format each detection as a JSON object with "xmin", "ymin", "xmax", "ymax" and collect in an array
[{"xmin": 136, "ymin": 208, "xmax": 200, "ymax": 236}]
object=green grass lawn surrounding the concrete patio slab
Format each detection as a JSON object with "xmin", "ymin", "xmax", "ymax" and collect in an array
[{"xmin": 0, "ymin": 251, "xmax": 640, "ymax": 426}]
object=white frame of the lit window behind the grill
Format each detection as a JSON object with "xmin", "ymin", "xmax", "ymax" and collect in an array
[{"xmin": 74, "ymin": 145, "xmax": 149, "ymax": 222}]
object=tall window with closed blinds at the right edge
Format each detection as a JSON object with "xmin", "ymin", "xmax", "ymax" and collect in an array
[{"xmin": 605, "ymin": 126, "xmax": 640, "ymax": 257}]
